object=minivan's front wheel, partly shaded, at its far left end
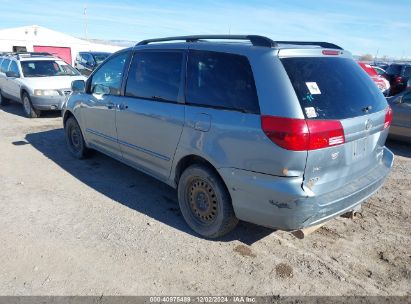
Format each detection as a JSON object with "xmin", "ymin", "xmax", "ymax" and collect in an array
[{"xmin": 64, "ymin": 117, "xmax": 90, "ymax": 159}]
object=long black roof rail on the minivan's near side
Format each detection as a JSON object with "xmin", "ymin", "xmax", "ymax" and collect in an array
[{"xmin": 136, "ymin": 35, "xmax": 277, "ymax": 47}]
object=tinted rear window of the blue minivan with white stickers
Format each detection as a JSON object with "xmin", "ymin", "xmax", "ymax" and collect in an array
[{"xmin": 281, "ymin": 57, "xmax": 387, "ymax": 119}]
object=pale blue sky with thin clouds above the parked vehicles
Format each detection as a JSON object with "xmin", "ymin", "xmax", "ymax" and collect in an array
[{"xmin": 0, "ymin": 0, "xmax": 411, "ymax": 58}]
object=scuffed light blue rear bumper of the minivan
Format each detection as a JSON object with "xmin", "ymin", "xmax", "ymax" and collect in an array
[{"xmin": 219, "ymin": 148, "xmax": 394, "ymax": 231}]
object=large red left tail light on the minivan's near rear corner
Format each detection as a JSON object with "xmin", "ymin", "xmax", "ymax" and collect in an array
[{"xmin": 261, "ymin": 116, "xmax": 345, "ymax": 151}]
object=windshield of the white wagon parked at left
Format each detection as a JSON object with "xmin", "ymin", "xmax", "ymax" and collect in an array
[{"xmin": 20, "ymin": 60, "xmax": 80, "ymax": 77}]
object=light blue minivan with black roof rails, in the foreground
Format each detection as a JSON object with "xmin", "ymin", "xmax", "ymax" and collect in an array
[{"xmin": 63, "ymin": 36, "xmax": 393, "ymax": 238}]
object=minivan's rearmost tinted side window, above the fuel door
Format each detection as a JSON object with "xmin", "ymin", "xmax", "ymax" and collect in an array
[{"xmin": 186, "ymin": 50, "xmax": 260, "ymax": 114}]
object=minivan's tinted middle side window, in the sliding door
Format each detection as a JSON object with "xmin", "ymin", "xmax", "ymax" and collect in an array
[{"xmin": 125, "ymin": 51, "xmax": 183, "ymax": 102}]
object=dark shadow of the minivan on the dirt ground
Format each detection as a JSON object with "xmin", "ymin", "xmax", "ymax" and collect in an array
[{"xmin": 25, "ymin": 128, "xmax": 273, "ymax": 245}]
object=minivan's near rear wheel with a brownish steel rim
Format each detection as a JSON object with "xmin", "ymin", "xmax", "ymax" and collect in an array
[{"xmin": 178, "ymin": 164, "xmax": 238, "ymax": 238}]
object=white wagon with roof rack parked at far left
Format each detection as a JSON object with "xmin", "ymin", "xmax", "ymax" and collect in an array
[{"xmin": 0, "ymin": 53, "xmax": 86, "ymax": 118}]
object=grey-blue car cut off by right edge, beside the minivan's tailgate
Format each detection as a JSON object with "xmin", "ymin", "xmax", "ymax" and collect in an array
[{"xmin": 387, "ymin": 89, "xmax": 411, "ymax": 142}]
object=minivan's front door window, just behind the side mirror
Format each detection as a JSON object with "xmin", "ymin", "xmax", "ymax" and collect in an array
[{"xmin": 90, "ymin": 52, "xmax": 129, "ymax": 95}]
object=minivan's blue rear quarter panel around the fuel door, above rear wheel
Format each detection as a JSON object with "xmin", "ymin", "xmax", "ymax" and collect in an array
[{"xmin": 175, "ymin": 106, "xmax": 307, "ymax": 176}]
